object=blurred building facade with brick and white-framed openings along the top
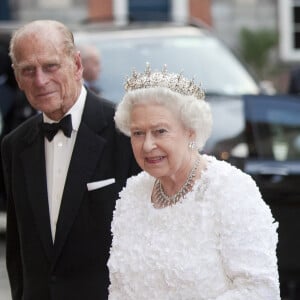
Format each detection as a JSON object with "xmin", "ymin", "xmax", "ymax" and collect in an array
[{"xmin": 4, "ymin": 0, "xmax": 300, "ymax": 62}]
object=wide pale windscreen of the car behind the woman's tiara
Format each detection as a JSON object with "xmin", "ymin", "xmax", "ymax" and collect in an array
[{"xmin": 75, "ymin": 28, "xmax": 258, "ymax": 102}]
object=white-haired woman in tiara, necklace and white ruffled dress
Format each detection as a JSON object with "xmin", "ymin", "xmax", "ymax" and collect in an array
[{"xmin": 108, "ymin": 66, "xmax": 280, "ymax": 300}]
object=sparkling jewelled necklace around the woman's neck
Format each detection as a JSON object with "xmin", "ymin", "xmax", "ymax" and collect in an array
[{"xmin": 151, "ymin": 157, "xmax": 200, "ymax": 208}]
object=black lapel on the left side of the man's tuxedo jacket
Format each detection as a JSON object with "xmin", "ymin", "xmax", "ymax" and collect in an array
[{"xmin": 21, "ymin": 122, "xmax": 53, "ymax": 260}]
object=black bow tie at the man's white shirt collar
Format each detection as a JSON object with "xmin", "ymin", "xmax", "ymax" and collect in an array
[{"xmin": 41, "ymin": 115, "xmax": 72, "ymax": 142}]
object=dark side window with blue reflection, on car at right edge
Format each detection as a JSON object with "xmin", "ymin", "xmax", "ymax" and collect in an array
[{"xmin": 245, "ymin": 95, "xmax": 300, "ymax": 161}]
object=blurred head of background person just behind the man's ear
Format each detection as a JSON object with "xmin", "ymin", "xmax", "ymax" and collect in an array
[{"xmin": 78, "ymin": 45, "xmax": 101, "ymax": 94}]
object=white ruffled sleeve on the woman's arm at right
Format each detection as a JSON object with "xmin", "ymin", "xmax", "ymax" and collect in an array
[{"xmin": 206, "ymin": 162, "xmax": 280, "ymax": 300}]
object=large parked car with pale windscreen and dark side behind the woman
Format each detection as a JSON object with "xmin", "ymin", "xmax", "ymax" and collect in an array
[{"xmin": 75, "ymin": 25, "xmax": 300, "ymax": 300}]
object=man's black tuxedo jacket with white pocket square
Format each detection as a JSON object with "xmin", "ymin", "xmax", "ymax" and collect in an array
[{"xmin": 2, "ymin": 92, "xmax": 139, "ymax": 300}]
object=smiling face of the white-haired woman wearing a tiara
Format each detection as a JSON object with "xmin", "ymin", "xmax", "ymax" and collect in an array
[{"xmin": 130, "ymin": 104, "xmax": 192, "ymax": 179}]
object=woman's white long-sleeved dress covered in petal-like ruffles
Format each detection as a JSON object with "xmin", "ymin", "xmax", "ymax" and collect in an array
[{"xmin": 108, "ymin": 156, "xmax": 280, "ymax": 300}]
